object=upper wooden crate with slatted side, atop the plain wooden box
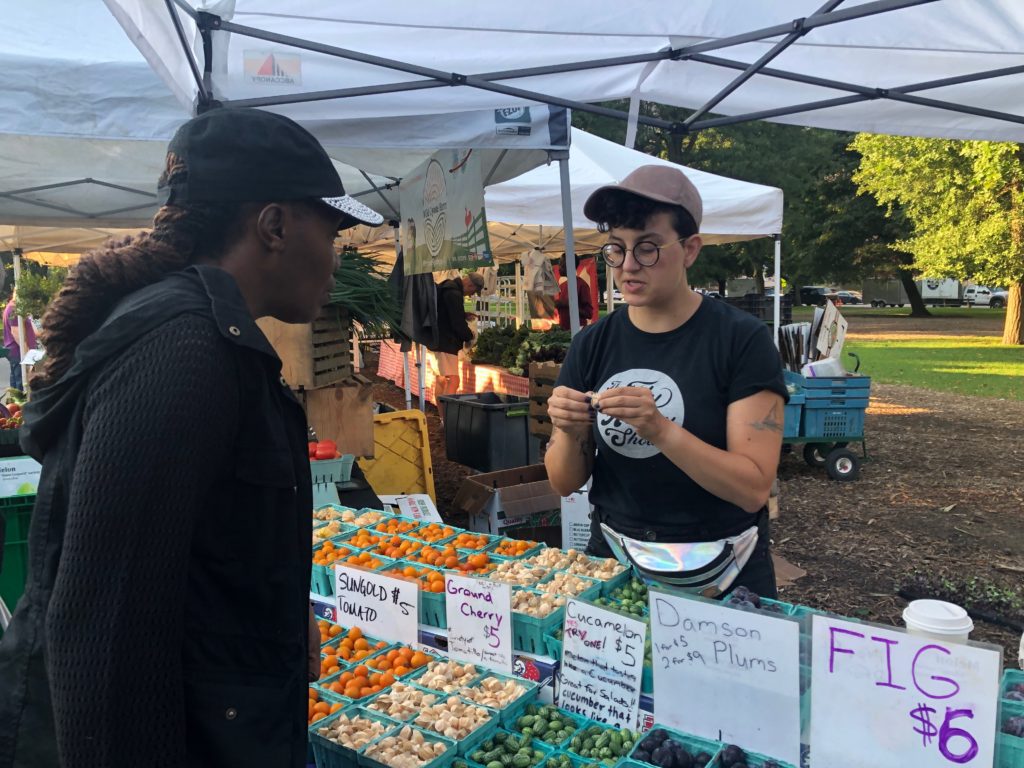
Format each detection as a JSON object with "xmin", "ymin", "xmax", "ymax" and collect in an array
[{"xmin": 257, "ymin": 306, "xmax": 353, "ymax": 389}]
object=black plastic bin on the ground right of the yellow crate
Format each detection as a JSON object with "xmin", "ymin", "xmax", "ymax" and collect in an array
[{"xmin": 440, "ymin": 392, "xmax": 541, "ymax": 472}]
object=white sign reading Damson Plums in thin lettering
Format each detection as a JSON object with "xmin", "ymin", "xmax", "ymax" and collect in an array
[{"xmin": 649, "ymin": 590, "xmax": 800, "ymax": 765}]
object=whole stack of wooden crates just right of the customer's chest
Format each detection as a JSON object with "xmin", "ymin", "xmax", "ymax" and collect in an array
[{"xmin": 258, "ymin": 306, "xmax": 374, "ymax": 457}]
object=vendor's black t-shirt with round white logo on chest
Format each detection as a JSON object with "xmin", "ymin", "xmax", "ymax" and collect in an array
[{"xmin": 558, "ymin": 298, "xmax": 786, "ymax": 541}]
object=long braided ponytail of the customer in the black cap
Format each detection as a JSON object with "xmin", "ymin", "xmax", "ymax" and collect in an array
[{"xmin": 32, "ymin": 155, "xmax": 257, "ymax": 387}]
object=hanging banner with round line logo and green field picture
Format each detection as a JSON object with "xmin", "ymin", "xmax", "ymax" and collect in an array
[{"xmin": 398, "ymin": 150, "xmax": 494, "ymax": 274}]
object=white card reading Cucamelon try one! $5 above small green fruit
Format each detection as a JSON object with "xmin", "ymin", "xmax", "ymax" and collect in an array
[{"xmin": 557, "ymin": 599, "xmax": 647, "ymax": 728}]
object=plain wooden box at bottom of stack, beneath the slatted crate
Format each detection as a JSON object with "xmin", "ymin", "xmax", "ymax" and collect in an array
[{"xmin": 295, "ymin": 374, "xmax": 374, "ymax": 457}]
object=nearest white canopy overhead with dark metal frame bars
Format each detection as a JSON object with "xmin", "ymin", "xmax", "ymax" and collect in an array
[{"xmin": 105, "ymin": 0, "xmax": 1024, "ymax": 140}]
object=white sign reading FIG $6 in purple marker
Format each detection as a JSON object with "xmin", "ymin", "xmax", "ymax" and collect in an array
[{"xmin": 811, "ymin": 615, "xmax": 1002, "ymax": 768}]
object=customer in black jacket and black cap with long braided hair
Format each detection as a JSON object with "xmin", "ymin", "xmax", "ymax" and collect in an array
[{"xmin": 0, "ymin": 109, "xmax": 381, "ymax": 768}]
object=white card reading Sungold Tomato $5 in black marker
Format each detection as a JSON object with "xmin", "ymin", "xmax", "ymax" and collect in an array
[{"xmin": 334, "ymin": 565, "xmax": 420, "ymax": 645}]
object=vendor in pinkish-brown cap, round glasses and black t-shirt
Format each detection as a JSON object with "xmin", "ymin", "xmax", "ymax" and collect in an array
[{"xmin": 545, "ymin": 165, "xmax": 785, "ymax": 597}]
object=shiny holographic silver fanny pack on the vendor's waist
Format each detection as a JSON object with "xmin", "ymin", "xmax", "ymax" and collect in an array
[{"xmin": 601, "ymin": 522, "xmax": 758, "ymax": 598}]
